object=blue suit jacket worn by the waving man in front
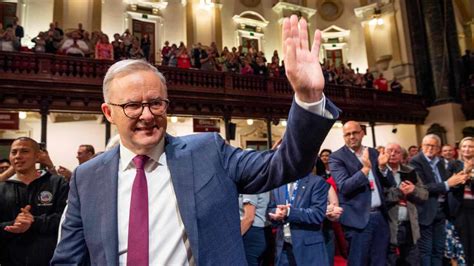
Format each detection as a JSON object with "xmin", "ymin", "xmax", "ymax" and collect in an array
[{"xmin": 52, "ymin": 101, "xmax": 338, "ymax": 265}]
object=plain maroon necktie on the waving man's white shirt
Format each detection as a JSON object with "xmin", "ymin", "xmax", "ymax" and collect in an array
[{"xmin": 127, "ymin": 155, "xmax": 149, "ymax": 266}]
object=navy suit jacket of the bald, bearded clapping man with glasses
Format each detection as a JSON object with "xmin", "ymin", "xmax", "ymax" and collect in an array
[{"xmin": 329, "ymin": 146, "xmax": 386, "ymax": 229}]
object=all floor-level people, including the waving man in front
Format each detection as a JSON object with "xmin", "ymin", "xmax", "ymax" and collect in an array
[{"xmin": 0, "ymin": 15, "xmax": 474, "ymax": 266}]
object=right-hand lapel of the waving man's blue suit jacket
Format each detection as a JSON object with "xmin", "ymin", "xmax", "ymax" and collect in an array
[{"xmin": 165, "ymin": 135, "xmax": 199, "ymax": 263}]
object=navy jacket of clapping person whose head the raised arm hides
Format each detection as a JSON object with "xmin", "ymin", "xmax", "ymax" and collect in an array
[{"xmin": 269, "ymin": 175, "xmax": 329, "ymax": 266}]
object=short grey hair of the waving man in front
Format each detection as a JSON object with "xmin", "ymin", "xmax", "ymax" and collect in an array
[{"xmin": 102, "ymin": 59, "xmax": 167, "ymax": 103}]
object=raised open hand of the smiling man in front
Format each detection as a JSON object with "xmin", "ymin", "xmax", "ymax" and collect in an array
[{"xmin": 282, "ymin": 15, "xmax": 324, "ymax": 103}]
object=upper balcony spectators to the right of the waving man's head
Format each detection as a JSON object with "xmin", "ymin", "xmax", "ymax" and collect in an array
[{"xmin": 161, "ymin": 41, "xmax": 403, "ymax": 92}]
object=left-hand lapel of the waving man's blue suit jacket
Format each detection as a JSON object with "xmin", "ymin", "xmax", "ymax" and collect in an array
[{"xmin": 96, "ymin": 146, "xmax": 120, "ymax": 265}]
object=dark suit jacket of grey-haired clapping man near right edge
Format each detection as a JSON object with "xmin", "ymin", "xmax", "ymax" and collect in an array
[{"xmin": 410, "ymin": 152, "xmax": 452, "ymax": 225}]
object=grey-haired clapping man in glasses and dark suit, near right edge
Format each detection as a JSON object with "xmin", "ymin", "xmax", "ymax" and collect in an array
[{"xmin": 410, "ymin": 134, "xmax": 467, "ymax": 266}]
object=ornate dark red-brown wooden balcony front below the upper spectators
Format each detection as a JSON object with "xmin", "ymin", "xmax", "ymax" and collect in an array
[{"xmin": 0, "ymin": 52, "xmax": 428, "ymax": 124}]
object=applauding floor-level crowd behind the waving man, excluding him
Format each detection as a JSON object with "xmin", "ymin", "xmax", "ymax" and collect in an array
[{"xmin": 0, "ymin": 125, "xmax": 474, "ymax": 266}]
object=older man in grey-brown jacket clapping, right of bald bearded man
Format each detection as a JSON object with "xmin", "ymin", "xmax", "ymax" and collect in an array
[{"xmin": 379, "ymin": 143, "xmax": 428, "ymax": 266}]
